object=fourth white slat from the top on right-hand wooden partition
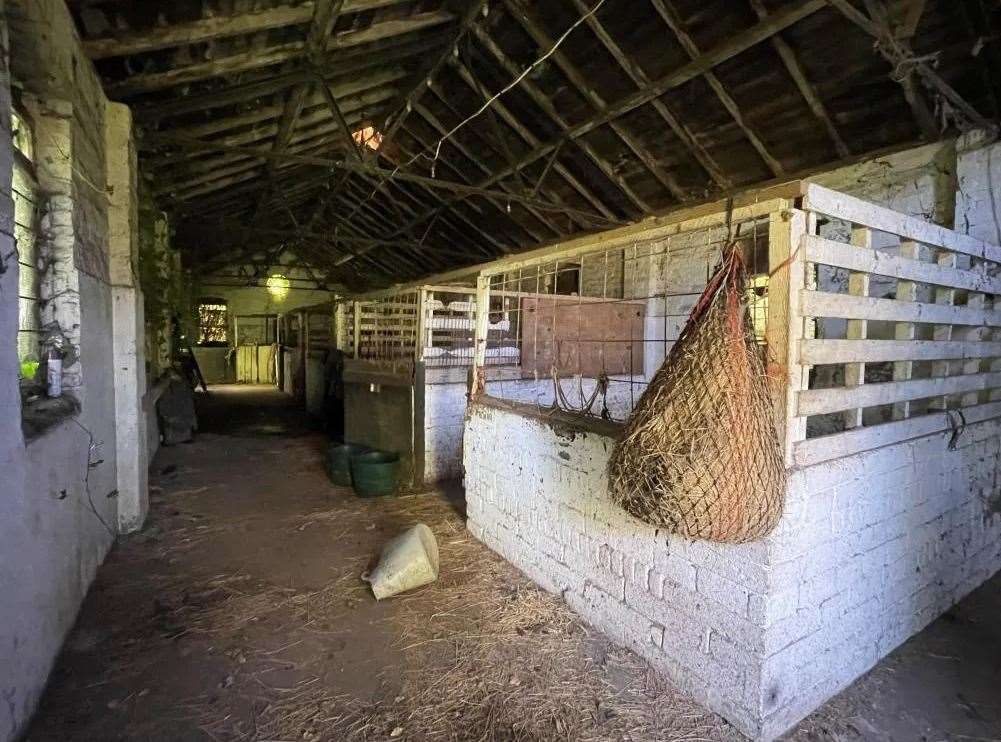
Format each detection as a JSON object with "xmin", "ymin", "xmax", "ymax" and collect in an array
[{"xmin": 800, "ymin": 340, "xmax": 1001, "ymax": 365}]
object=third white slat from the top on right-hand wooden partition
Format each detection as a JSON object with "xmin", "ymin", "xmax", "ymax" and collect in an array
[{"xmin": 800, "ymin": 288, "xmax": 1001, "ymax": 327}]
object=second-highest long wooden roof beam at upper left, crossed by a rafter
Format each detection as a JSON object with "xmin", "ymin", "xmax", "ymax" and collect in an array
[{"xmin": 106, "ymin": 11, "xmax": 454, "ymax": 98}]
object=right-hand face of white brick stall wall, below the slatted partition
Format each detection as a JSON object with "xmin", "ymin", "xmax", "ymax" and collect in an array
[{"xmin": 761, "ymin": 421, "xmax": 1001, "ymax": 733}]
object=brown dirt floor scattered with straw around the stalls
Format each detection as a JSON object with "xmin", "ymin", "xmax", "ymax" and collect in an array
[{"xmin": 21, "ymin": 387, "xmax": 1001, "ymax": 742}]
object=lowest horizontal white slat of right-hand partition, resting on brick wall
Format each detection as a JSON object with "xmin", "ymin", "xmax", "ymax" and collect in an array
[{"xmin": 793, "ymin": 402, "xmax": 1001, "ymax": 467}]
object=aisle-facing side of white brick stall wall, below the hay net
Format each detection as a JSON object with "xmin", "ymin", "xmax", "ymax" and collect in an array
[{"xmin": 463, "ymin": 404, "xmax": 778, "ymax": 735}]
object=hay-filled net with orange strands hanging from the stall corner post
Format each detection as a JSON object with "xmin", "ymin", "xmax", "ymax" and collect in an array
[{"xmin": 609, "ymin": 244, "xmax": 786, "ymax": 543}]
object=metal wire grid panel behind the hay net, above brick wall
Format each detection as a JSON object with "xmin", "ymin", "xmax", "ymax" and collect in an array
[{"xmin": 483, "ymin": 215, "xmax": 769, "ymax": 421}]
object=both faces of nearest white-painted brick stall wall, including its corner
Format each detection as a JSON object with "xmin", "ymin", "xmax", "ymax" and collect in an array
[{"xmin": 464, "ymin": 404, "xmax": 1001, "ymax": 739}]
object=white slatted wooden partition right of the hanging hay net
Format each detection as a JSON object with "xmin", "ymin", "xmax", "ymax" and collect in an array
[{"xmin": 769, "ymin": 185, "xmax": 1001, "ymax": 466}]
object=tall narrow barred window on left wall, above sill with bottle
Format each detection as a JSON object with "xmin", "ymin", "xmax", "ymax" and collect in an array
[{"xmin": 11, "ymin": 105, "xmax": 42, "ymax": 381}]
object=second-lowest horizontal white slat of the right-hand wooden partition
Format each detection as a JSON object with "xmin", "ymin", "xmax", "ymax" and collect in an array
[{"xmin": 797, "ymin": 372, "xmax": 1001, "ymax": 417}]
